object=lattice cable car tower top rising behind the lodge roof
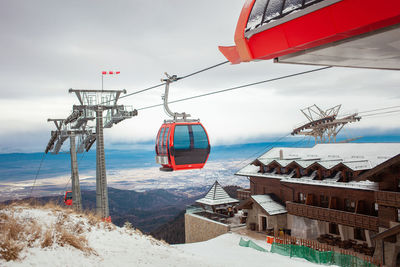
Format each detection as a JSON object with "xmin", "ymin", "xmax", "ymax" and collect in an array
[{"xmin": 291, "ymin": 104, "xmax": 361, "ymax": 144}]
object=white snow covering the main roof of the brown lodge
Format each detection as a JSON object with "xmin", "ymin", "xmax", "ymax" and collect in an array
[{"xmin": 236, "ymin": 143, "xmax": 400, "ymax": 190}]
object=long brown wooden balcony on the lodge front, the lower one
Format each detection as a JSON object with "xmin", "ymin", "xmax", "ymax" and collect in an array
[{"xmin": 286, "ymin": 201, "xmax": 378, "ymax": 232}]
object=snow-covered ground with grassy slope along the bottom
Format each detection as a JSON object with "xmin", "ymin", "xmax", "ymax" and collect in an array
[{"xmin": 0, "ymin": 207, "xmax": 313, "ymax": 267}]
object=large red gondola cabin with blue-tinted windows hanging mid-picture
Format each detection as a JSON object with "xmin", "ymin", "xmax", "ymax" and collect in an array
[{"xmin": 156, "ymin": 122, "xmax": 210, "ymax": 171}]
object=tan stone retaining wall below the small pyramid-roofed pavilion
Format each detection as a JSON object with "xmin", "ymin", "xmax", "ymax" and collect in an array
[{"xmin": 185, "ymin": 213, "xmax": 230, "ymax": 243}]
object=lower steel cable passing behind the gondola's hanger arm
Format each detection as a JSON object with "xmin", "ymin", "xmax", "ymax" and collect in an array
[{"xmin": 137, "ymin": 66, "xmax": 332, "ymax": 110}]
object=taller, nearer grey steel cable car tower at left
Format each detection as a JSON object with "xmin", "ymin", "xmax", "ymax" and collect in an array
[{"xmin": 69, "ymin": 89, "xmax": 137, "ymax": 219}]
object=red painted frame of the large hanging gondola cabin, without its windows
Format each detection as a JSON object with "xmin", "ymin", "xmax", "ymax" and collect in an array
[{"xmin": 156, "ymin": 122, "xmax": 210, "ymax": 171}]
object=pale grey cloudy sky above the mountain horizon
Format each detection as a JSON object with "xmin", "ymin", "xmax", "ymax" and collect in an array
[{"xmin": 0, "ymin": 0, "xmax": 400, "ymax": 153}]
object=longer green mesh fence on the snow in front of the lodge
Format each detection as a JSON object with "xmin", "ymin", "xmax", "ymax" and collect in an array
[{"xmin": 271, "ymin": 243, "xmax": 377, "ymax": 267}]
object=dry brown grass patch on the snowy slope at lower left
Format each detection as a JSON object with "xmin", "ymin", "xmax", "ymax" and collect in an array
[{"xmin": 0, "ymin": 202, "xmax": 98, "ymax": 261}]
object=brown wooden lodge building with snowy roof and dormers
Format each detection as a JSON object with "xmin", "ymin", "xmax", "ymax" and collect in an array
[{"xmin": 236, "ymin": 143, "xmax": 400, "ymax": 266}]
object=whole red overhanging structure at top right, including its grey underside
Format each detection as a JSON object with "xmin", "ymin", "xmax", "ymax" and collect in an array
[{"xmin": 219, "ymin": 0, "xmax": 400, "ymax": 70}]
